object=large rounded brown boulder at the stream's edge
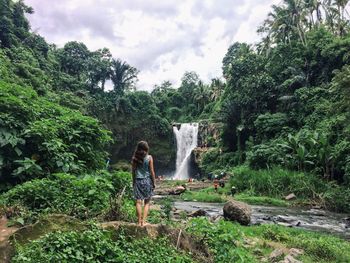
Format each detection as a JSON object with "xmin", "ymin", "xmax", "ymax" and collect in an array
[{"xmin": 223, "ymin": 200, "xmax": 252, "ymax": 225}]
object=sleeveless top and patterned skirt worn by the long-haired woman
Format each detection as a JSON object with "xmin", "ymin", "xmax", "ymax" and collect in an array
[{"xmin": 134, "ymin": 155, "xmax": 153, "ymax": 200}]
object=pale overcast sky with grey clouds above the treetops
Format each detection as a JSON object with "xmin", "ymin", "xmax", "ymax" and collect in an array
[{"xmin": 25, "ymin": 0, "xmax": 280, "ymax": 90}]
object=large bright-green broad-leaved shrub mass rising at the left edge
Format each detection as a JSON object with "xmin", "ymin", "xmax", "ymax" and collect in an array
[{"xmin": 0, "ymin": 82, "xmax": 111, "ymax": 186}]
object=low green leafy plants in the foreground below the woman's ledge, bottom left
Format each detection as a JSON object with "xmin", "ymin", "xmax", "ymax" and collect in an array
[{"xmin": 12, "ymin": 227, "xmax": 193, "ymax": 263}]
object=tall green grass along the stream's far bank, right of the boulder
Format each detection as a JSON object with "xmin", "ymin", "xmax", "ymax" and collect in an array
[{"xmin": 230, "ymin": 166, "xmax": 350, "ymax": 213}]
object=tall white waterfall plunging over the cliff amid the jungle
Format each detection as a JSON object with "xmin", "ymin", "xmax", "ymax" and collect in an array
[{"xmin": 173, "ymin": 123, "xmax": 198, "ymax": 180}]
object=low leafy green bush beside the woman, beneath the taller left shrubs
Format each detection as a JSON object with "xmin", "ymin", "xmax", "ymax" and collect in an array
[{"xmin": 1, "ymin": 172, "xmax": 131, "ymax": 220}]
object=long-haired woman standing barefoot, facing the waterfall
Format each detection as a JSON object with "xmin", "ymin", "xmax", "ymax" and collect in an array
[{"xmin": 132, "ymin": 141, "xmax": 156, "ymax": 226}]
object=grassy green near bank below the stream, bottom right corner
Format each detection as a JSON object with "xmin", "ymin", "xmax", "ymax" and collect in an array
[{"xmin": 186, "ymin": 218, "xmax": 350, "ymax": 263}]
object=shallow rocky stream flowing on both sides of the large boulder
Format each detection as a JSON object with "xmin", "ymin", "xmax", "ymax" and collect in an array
[{"xmin": 174, "ymin": 201, "xmax": 350, "ymax": 240}]
